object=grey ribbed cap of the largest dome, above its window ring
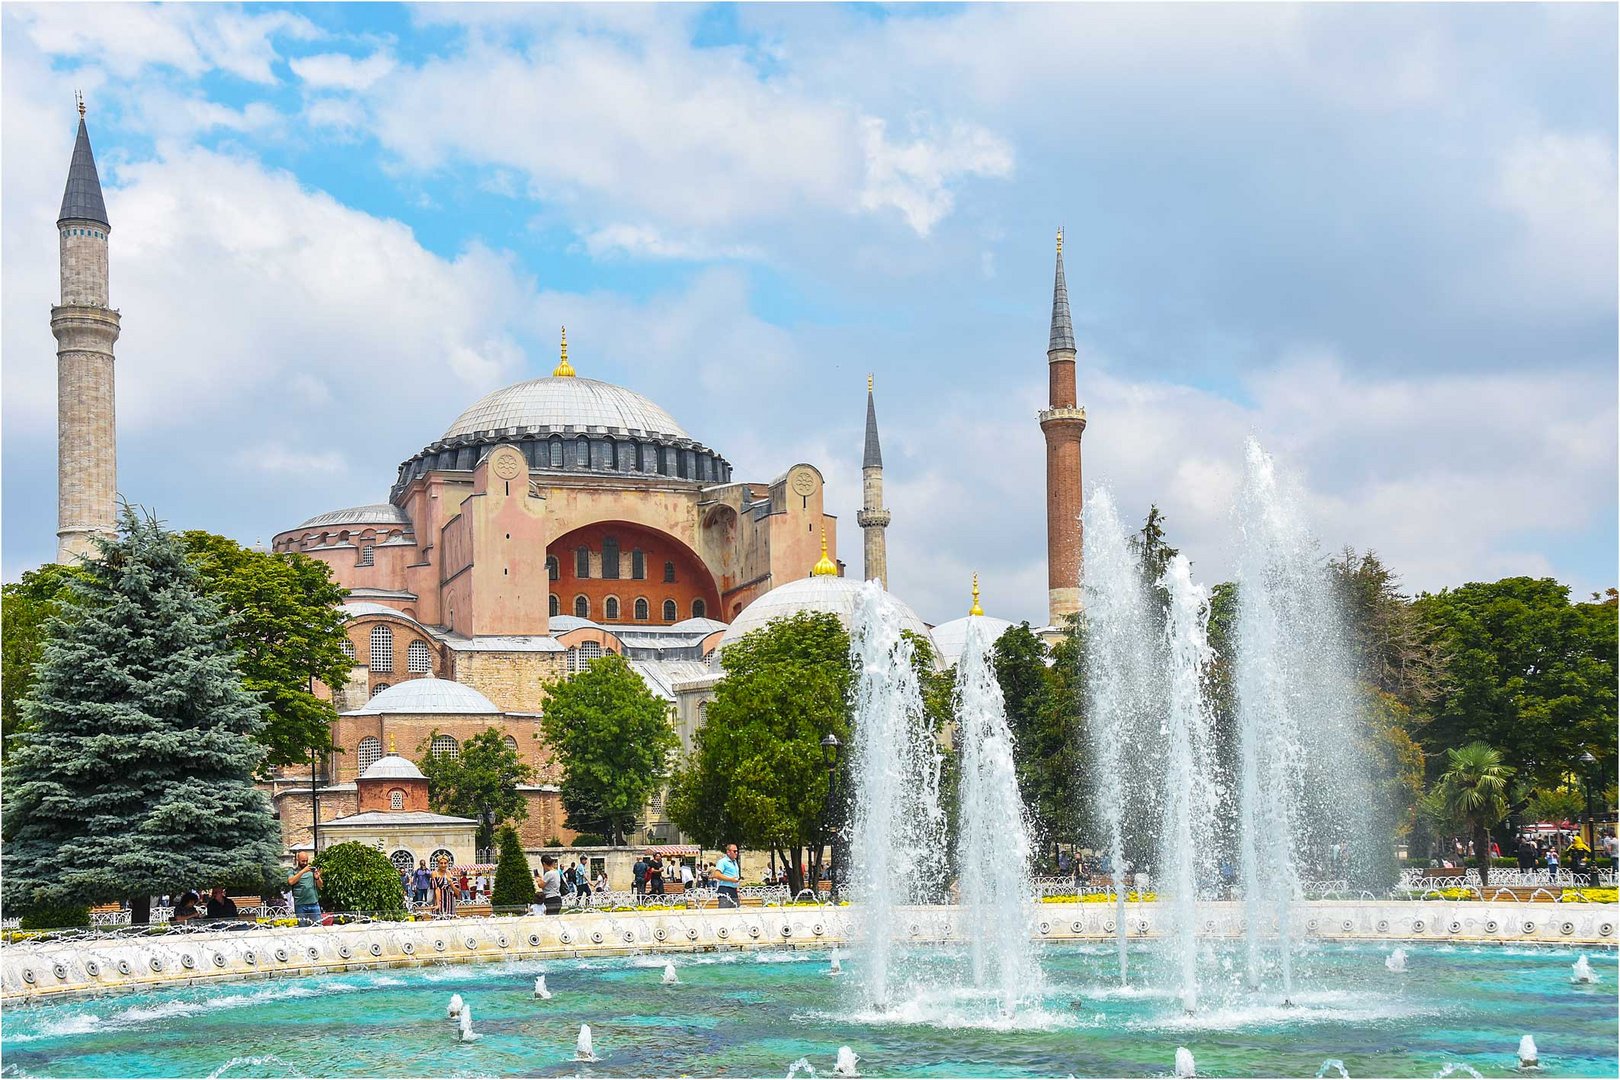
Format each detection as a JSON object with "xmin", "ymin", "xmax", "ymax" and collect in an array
[{"xmin": 444, "ymin": 376, "xmax": 692, "ymax": 439}]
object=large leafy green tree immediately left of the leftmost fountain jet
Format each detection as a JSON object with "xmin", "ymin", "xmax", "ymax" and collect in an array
[{"xmin": 669, "ymin": 612, "xmax": 852, "ymax": 894}]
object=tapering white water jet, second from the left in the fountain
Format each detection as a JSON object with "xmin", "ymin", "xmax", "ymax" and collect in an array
[{"xmin": 956, "ymin": 612, "xmax": 1042, "ymax": 1014}]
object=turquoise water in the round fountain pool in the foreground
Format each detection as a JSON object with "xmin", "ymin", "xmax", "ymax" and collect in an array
[{"xmin": 0, "ymin": 944, "xmax": 1620, "ymax": 1077}]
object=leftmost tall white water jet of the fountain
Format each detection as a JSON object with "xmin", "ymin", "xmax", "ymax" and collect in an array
[{"xmin": 851, "ymin": 581, "xmax": 944, "ymax": 1007}]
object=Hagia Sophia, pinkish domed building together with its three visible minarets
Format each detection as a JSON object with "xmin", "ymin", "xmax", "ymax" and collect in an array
[{"xmin": 50, "ymin": 105, "xmax": 1085, "ymax": 866}]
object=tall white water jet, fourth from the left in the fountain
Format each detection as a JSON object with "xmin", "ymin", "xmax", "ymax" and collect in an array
[{"xmin": 1158, "ymin": 555, "xmax": 1217, "ymax": 1012}]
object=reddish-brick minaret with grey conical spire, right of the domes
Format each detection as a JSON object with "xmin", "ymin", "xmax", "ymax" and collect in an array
[{"xmin": 1040, "ymin": 230, "xmax": 1085, "ymax": 625}]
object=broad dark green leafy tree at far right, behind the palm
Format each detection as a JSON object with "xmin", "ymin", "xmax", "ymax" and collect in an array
[{"xmin": 1416, "ymin": 578, "xmax": 1620, "ymax": 787}]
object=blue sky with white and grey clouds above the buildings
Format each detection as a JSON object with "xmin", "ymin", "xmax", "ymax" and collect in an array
[{"xmin": 0, "ymin": 3, "xmax": 1620, "ymax": 625}]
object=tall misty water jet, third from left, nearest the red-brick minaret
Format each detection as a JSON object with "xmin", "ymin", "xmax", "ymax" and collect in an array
[{"xmin": 1081, "ymin": 487, "xmax": 1158, "ymax": 983}]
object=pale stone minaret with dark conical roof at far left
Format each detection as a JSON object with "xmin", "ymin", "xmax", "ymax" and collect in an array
[{"xmin": 50, "ymin": 100, "xmax": 118, "ymax": 563}]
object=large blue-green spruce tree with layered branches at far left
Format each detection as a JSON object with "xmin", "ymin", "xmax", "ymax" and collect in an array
[{"xmin": 5, "ymin": 507, "xmax": 280, "ymax": 921}]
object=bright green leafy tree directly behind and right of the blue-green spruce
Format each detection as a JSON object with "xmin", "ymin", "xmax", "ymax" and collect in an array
[{"xmin": 181, "ymin": 531, "xmax": 353, "ymax": 766}]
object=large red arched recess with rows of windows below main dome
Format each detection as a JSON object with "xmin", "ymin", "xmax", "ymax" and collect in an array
[{"xmin": 546, "ymin": 521, "xmax": 721, "ymax": 627}]
